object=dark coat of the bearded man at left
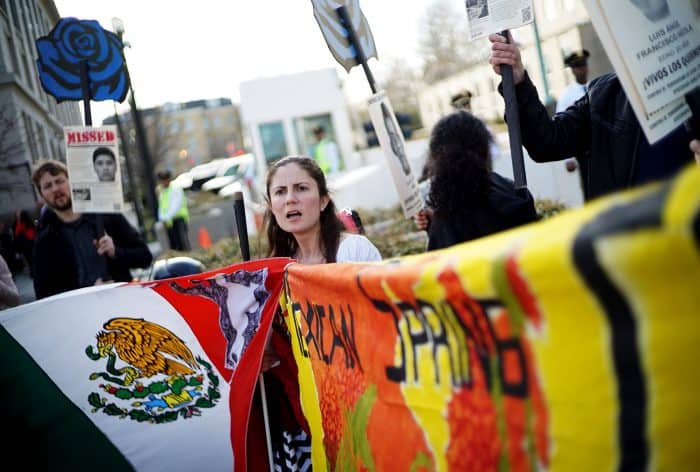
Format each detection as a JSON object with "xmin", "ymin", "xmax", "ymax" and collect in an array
[{"xmin": 34, "ymin": 209, "xmax": 153, "ymax": 300}]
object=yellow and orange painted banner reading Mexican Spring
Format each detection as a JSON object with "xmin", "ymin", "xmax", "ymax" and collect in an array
[{"xmin": 284, "ymin": 167, "xmax": 700, "ymax": 471}]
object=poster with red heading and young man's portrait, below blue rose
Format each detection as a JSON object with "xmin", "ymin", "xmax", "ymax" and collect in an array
[{"xmin": 63, "ymin": 126, "xmax": 124, "ymax": 213}]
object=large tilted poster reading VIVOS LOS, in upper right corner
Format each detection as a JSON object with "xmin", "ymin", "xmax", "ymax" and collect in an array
[{"xmin": 584, "ymin": 0, "xmax": 700, "ymax": 144}]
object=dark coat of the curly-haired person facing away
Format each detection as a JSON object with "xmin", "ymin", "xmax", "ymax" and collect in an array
[{"xmin": 428, "ymin": 172, "xmax": 539, "ymax": 251}]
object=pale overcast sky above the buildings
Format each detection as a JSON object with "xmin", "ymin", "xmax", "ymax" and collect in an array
[{"xmin": 55, "ymin": 0, "xmax": 430, "ymax": 125}]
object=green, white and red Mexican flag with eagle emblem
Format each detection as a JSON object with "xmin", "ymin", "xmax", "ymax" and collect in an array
[{"xmin": 0, "ymin": 258, "xmax": 290, "ymax": 471}]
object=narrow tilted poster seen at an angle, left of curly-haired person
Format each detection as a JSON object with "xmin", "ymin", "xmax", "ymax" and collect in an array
[{"xmin": 368, "ymin": 92, "xmax": 423, "ymax": 218}]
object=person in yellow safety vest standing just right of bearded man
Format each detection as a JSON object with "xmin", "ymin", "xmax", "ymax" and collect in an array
[{"xmin": 158, "ymin": 169, "xmax": 191, "ymax": 251}]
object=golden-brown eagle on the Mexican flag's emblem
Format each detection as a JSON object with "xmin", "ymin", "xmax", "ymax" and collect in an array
[{"xmin": 97, "ymin": 318, "xmax": 198, "ymax": 385}]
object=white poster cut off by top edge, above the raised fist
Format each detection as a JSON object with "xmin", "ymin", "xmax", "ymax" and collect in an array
[{"xmin": 464, "ymin": 0, "xmax": 535, "ymax": 41}]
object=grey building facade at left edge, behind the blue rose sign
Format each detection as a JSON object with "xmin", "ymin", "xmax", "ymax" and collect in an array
[{"xmin": 0, "ymin": 0, "xmax": 82, "ymax": 217}]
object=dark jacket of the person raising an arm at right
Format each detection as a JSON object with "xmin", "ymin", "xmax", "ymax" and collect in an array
[{"xmin": 499, "ymin": 73, "xmax": 692, "ymax": 200}]
